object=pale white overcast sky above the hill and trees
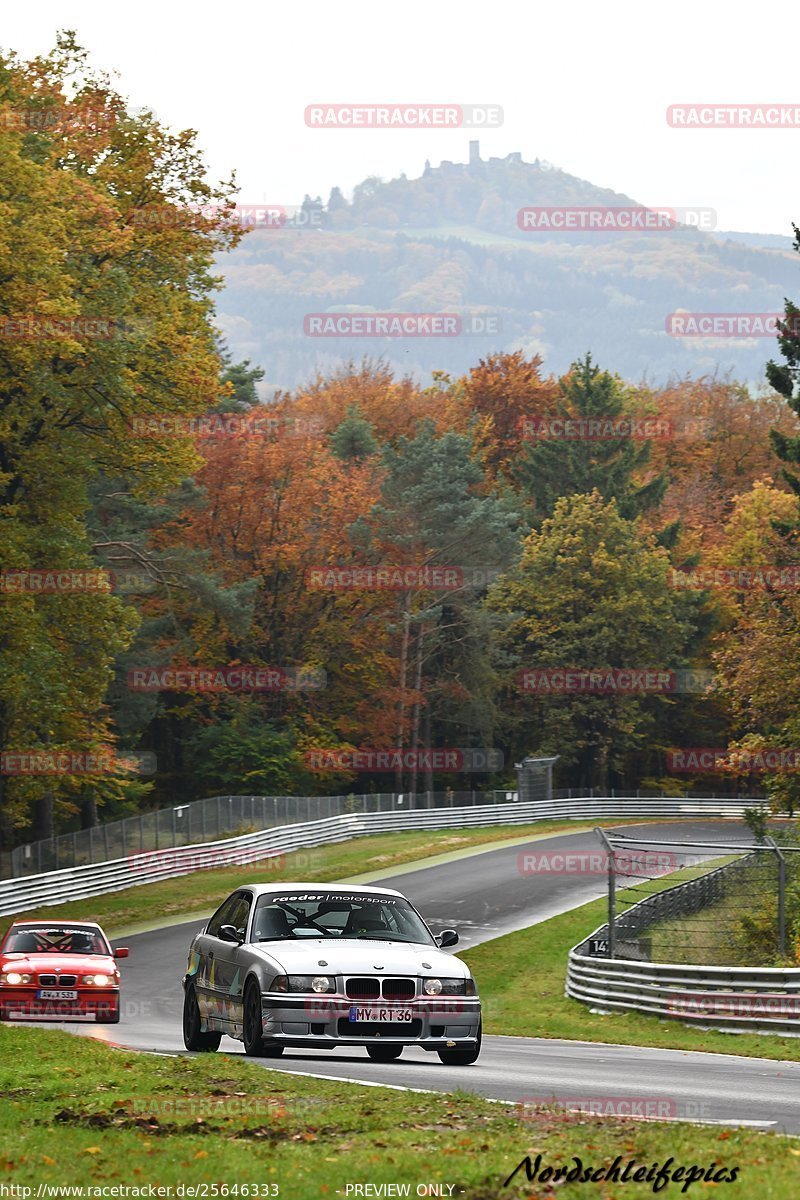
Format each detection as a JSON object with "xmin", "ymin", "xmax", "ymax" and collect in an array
[{"xmin": 0, "ymin": 0, "xmax": 800, "ymax": 234}]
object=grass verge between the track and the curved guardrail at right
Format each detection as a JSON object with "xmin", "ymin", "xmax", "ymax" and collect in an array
[{"xmin": 462, "ymin": 860, "xmax": 800, "ymax": 1060}]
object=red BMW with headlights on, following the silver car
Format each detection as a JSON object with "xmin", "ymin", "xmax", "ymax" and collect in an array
[{"xmin": 0, "ymin": 920, "xmax": 128, "ymax": 1025}]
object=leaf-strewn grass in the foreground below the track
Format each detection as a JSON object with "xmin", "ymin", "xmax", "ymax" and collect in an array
[{"xmin": 0, "ymin": 1027, "xmax": 800, "ymax": 1200}]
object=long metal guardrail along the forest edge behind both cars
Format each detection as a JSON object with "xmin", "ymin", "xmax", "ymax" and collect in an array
[{"xmin": 0, "ymin": 797, "xmax": 762, "ymax": 916}]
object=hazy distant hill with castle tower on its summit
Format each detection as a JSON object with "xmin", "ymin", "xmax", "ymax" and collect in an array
[{"xmin": 219, "ymin": 144, "xmax": 795, "ymax": 388}]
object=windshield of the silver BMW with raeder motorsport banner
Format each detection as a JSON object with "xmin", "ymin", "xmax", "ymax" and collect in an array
[{"xmin": 251, "ymin": 892, "xmax": 435, "ymax": 946}]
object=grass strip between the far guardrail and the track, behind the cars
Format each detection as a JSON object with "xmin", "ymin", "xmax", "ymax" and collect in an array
[{"xmin": 0, "ymin": 821, "xmax": 645, "ymax": 937}]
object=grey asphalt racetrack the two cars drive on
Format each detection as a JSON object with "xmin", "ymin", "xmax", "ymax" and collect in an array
[{"xmin": 15, "ymin": 821, "xmax": 800, "ymax": 1134}]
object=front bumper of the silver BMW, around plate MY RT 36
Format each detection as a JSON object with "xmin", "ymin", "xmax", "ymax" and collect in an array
[{"xmin": 261, "ymin": 994, "xmax": 481, "ymax": 1050}]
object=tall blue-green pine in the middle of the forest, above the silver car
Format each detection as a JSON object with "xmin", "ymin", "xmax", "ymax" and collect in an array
[{"xmin": 353, "ymin": 425, "xmax": 518, "ymax": 791}]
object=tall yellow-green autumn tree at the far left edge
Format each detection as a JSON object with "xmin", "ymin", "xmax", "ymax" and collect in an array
[{"xmin": 0, "ymin": 35, "xmax": 239, "ymax": 836}]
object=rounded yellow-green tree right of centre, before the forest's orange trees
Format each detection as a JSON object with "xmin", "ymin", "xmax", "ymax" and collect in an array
[{"xmin": 487, "ymin": 491, "xmax": 692, "ymax": 787}]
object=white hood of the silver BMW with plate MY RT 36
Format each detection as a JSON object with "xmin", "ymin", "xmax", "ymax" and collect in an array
[{"xmin": 247, "ymin": 937, "xmax": 469, "ymax": 979}]
